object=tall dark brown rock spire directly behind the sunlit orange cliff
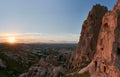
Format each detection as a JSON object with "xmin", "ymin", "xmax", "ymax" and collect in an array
[{"xmin": 69, "ymin": 4, "xmax": 108, "ymax": 69}]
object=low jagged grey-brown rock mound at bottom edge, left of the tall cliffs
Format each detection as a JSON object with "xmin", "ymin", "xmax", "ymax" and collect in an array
[{"xmin": 19, "ymin": 58, "xmax": 66, "ymax": 77}]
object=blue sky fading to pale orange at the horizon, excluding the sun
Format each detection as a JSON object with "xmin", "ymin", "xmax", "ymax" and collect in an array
[{"xmin": 0, "ymin": 0, "xmax": 117, "ymax": 43}]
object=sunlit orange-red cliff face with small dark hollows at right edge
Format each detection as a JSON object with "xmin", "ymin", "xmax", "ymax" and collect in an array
[{"xmin": 90, "ymin": 0, "xmax": 120, "ymax": 77}]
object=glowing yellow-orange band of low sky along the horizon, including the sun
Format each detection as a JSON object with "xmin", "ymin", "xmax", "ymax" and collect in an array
[{"xmin": 0, "ymin": 33, "xmax": 79, "ymax": 44}]
